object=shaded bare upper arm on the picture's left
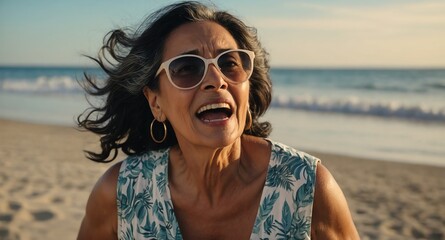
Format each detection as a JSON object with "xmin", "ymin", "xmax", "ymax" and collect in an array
[{"xmin": 77, "ymin": 163, "xmax": 121, "ymax": 239}]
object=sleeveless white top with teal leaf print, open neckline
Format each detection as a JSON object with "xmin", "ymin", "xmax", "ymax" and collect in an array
[{"xmin": 117, "ymin": 140, "xmax": 319, "ymax": 240}]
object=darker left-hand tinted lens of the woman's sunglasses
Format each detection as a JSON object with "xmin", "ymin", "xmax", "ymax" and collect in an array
[{"xmin": 169, "ymin": 56, "xmax": 205, "ymax": 88}]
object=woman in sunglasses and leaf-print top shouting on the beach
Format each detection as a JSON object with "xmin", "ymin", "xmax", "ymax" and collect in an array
[{"xmin": 78, "ymin": 2, "xmax": 358, "ymax": 239}]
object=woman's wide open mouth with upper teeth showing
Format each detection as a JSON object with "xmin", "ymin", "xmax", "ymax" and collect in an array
[{"xmin": 196, "ymin": 103, "xmax": 233, "ymax": 123}]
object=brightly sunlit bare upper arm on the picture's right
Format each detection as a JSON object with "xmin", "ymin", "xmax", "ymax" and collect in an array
[{"xmin": 311, "ymin": 163, "xmax": 360, "ymax": 239}]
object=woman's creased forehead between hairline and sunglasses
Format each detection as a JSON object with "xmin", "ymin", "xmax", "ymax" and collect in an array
[{"xmin": 163, "ymin": 21, "xmax": 238, "ymax": 60}]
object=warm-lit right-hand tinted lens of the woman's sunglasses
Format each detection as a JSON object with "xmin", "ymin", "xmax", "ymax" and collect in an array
[{"xmin": 218, "ymin": 51, "xmax": 252, "ymax": 82}]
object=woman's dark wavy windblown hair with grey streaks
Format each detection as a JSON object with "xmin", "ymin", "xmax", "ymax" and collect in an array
[{"xmin": 77, "ymin": 1, "xmax": 272, "ymax": 162}]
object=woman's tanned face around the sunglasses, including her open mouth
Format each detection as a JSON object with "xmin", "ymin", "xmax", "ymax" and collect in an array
[{"xmin": 149, "ymin": 21, "xmax": 249, "ymax": 148}]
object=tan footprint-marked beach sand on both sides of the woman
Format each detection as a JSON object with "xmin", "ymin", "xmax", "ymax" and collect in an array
[{"xmin": 0, "ymin": 120, "xmax": 445, "ymax": 240}]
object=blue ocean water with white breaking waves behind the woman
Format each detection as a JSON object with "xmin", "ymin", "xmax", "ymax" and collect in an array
[{"xmin": 0, "ymin": 67, "xmax": 445, "ymax": 166}]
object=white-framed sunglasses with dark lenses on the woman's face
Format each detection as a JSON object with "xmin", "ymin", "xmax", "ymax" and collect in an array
[{"xmin": 156, "ymin": 49, "xmax": 255, "ymax": 90}]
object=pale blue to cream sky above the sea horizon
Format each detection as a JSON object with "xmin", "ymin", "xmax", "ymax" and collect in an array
[{"xmin": 0, "ymin": 0, "xmax": 445, "ymax": 68}]
